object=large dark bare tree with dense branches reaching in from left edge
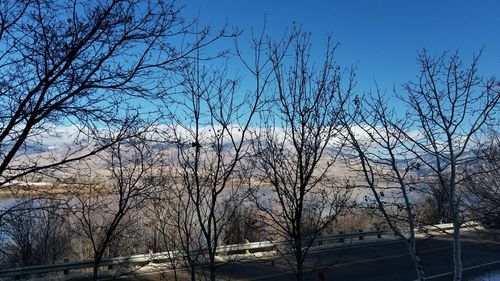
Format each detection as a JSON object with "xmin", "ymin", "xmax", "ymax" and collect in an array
[{"xmin": 0, "ymin": 0, "xmax": 229, "ymax": 208}]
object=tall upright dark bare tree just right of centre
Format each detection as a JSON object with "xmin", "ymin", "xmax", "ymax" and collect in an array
[{"xmin": 253, "ymin": 30, "xmax": 352, "ymax": 280}]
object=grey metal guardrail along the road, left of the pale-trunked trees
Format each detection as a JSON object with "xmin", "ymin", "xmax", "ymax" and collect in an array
[{"xmin": 0, "ymin": 230, "xmax": 388, "ymax": 278}]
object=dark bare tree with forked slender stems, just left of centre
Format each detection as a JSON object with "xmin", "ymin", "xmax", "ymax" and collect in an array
[{"xmin": 159, "ymin": 34, "xmax": 268, "ymax": 280}]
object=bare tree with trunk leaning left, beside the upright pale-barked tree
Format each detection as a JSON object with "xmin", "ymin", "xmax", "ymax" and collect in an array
[{"xmin": 344, "ymin": 91, "xmax": 425, "ymax": 280}]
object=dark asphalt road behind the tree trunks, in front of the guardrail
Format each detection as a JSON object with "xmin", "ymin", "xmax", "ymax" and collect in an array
[{"xmin": 98, "ymin": 235, "xmax": 500, "ymax": 281}]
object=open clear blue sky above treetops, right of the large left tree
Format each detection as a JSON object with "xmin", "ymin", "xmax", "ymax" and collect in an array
[{"xmin": 178, "ymin": 0, "xmax": 500, "ymax": 95}]
